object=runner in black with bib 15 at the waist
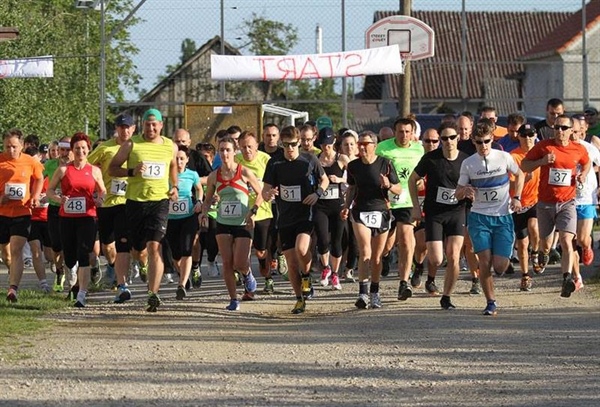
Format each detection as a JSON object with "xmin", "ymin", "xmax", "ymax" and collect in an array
[{"xmin": 340, "ymin": 131, "xmax": 402, "ymax": 309}]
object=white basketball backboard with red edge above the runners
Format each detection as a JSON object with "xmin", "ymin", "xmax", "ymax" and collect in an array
[{"xmin": 365, "ymin": 16, "xmax": 435, "ymax": 61}]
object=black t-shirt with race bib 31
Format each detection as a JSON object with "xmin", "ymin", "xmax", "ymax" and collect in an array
[{"xmin": 263, "ymin": 153, "xmax": 325, "ymax": 229}]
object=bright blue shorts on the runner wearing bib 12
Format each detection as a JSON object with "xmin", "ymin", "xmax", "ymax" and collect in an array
[{"xmin": 467, "ymin": 212, "xmax": 515, "ymax": 259}]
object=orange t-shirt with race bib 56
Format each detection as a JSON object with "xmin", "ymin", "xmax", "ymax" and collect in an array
[{"xmin": 0, "ymin": 153, "xmax": 44, "ymax": 218}]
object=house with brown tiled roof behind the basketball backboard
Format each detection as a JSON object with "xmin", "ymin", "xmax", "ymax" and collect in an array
[{"xmin": 360, "ymin": 1, "xmax": 600, "ymax": 117}]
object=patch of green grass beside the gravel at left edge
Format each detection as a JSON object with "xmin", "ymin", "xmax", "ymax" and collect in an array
[{"xmin": 0, "ymin": 290, "xmax": 71, "ymax": 359}]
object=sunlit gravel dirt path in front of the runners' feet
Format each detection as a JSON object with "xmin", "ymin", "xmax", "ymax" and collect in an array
[{"xmin": 0, "ymin": 267, "xmax": 600, "ymax": 407}]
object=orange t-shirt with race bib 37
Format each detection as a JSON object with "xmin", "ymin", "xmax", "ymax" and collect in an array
[{"xmin": 525, "ymin": 139, "xmax": 590, "ymax": 203}]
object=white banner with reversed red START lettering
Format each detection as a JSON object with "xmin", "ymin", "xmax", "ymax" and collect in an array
[{"xmin": 210, "ymin": 45, "xmax": 402, "ymax": 81}]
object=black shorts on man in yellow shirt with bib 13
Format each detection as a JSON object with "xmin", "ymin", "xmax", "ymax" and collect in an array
[{"xmin": 125, "ymin": 199, "xmax": 169, "ymax": 251}]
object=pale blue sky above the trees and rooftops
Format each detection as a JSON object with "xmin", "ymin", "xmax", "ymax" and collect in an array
[{"xmin": 126, "ymin": 0, "xmax": 585, "ymax": 100}]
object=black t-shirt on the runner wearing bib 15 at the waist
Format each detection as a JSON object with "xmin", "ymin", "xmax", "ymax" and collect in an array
[{"xmin": 348, "ymin": 156, "xmax": 400, "ymax": 211}]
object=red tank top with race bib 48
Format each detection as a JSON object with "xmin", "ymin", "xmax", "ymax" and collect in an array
[{"xmin": 59, "ymin": 163, "xmax": 96, "ymax": 218}]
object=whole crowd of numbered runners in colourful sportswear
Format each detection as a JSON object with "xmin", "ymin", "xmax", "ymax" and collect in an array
[{"xmin": 0, "ymin": 99, "xmax": 600, "ymax": 315}]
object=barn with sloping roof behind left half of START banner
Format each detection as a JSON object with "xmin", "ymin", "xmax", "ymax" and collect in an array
[{"xmin": 136, "ymin": 36, "xmax": 264, "ymax": 135}]
